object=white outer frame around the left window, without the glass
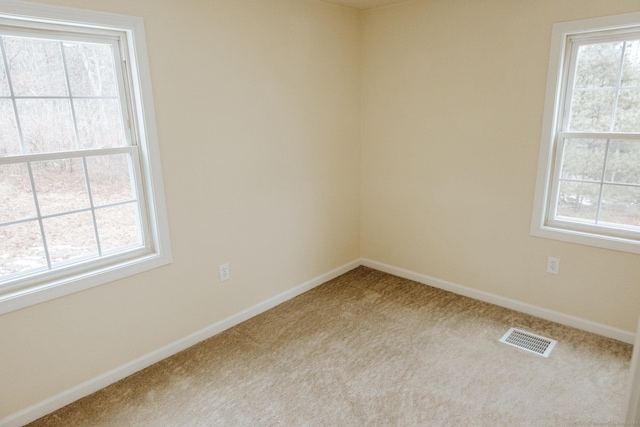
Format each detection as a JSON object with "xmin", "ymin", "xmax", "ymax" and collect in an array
[{"xmin": 0, "ymin": 0, "xmax": 172, "ymax": 314}]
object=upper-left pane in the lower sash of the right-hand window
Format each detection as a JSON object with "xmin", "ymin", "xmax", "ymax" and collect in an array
[{"xmin": 561, "ymin": 139, "xmax": 607, "ymax": 181}]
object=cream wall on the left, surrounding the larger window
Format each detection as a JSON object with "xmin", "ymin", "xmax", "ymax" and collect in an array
[{"xmin": 0, "ymin": 0, "xmax": 360, "ymax": 419}]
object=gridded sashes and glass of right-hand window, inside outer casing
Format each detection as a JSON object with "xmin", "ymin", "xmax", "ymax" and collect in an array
[{"xmin": 547, "ymin": 30, "xmax": 640, "ymax": 239}]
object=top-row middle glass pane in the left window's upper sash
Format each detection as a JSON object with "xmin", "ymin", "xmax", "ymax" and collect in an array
[{"xmin": 2, "ymin": 36, "xmax": 67, "ymax": 96}]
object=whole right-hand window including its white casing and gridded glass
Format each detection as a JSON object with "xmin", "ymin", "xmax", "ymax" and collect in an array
[{"xmin": 532, "ymin": 13, "xmax": 640, "ymax": 253}]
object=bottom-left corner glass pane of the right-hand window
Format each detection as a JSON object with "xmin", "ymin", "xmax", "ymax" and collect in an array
[{"xmin": 557, "ymin": 181, "xmax": 600, "ymax": 223}]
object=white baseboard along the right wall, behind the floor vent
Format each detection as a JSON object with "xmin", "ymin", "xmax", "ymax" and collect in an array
[{"xmin": 360, "ymin": 258, "xmax": 635, "ymax": 344}]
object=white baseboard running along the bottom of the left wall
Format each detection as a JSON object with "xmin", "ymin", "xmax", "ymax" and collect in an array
[{"xmin": 0, "ymin": 260, "xmax": 360, "ymax": 427}]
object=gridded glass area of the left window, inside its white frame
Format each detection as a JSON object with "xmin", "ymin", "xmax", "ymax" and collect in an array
[{"xmin": 0, "ymin": 27, "xmax": 150, "ymax": 290}]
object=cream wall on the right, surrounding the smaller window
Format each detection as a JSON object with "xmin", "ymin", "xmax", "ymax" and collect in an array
[{"xmin": 361, "ymin": 0, "xmax": 640, "ymax": 331}]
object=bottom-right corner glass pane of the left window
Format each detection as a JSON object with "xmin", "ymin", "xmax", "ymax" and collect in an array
[{"xmin": 96, "ymin": 203, "xmax": 142, "ymax": 253}]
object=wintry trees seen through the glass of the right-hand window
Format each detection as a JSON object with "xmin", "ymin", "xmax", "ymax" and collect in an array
[{"xmin": 558, "ymin": 40, "xmax": 640, "ymax": 227}]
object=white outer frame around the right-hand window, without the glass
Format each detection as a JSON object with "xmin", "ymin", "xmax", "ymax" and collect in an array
[{"xmin": 531, "ymin": 12, "xmax": 640, "ymax": 254}]
